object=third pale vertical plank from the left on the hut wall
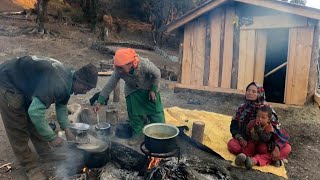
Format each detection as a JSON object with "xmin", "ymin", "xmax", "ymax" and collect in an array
[{"xmin": 208, "ymin": 9, "xmax": 223, "ymax": 87}]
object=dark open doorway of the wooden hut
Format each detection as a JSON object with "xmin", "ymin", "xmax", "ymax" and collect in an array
[{"xmin": 263, "ymin": 29, "xmax": 289, "ymax": 103}]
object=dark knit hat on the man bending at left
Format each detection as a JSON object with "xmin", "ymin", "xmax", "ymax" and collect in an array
[{"xmin": 74, "ymin": 63, "xmax": 98, "ymax": 88}]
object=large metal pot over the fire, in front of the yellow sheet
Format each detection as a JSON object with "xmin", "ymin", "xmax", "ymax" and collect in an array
[{"xmin": 143, "ymin": 123, "xmax": 179, "ymax": 153}]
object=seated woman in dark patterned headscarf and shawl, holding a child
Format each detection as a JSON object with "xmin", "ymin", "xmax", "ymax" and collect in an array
[{"xmin": 228, "ymin": 82, "xmax": 291, "ymax": 167}]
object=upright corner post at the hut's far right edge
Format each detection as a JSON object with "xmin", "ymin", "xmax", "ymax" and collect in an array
[{"xmin": 306, "ymin": 21, "xmax": 320, "ymax": 103}]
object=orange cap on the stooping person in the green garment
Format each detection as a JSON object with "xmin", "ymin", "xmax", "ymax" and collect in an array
[{"xmin": 114, "ymin": 48, "xmax": 139, "ymax": 68}]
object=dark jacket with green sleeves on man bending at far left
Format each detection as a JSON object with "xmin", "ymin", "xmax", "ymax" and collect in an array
[{"xmin": 0, "ymin": 56, "xmax": 74, "ymax": 141}]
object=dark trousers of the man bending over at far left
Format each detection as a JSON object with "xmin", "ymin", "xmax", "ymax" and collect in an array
[{"xmin": 0, "ymin": 87, "xmax": 50, "ymax": 171}]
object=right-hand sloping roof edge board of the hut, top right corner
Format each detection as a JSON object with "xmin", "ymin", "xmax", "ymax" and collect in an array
[{"xmin": 234, "ymin": 0, "xmax": 320, "ymax": 20}]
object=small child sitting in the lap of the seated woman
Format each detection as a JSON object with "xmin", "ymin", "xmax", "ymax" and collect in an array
[{"xmin": 235, "ymin": 106, "xmax": 281, "ymax": 170}]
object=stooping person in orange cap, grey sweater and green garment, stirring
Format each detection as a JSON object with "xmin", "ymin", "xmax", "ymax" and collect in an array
[{"xmin": 96, "ymin": 48, "xmax": 165, "ymax": 145}]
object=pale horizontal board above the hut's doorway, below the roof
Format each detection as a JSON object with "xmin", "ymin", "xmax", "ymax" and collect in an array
[{"xmin": 240, "ymin": 14, "xmax": 308, "ymax": 29}]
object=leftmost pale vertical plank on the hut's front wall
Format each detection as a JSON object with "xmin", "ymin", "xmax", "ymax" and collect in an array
[{"xmin": 181, "ymin": 23, "xmax": 194, "ymax": 85}]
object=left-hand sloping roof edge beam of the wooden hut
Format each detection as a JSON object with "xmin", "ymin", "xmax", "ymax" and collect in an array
[{"xmin": 160, "ymin": 0, "xmax": 228, "ymax": 32}]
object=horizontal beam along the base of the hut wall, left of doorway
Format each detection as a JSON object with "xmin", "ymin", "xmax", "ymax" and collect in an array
[{"xmin": 175, "ymin": 84, "xmax": 245, "ymax": 95}]
